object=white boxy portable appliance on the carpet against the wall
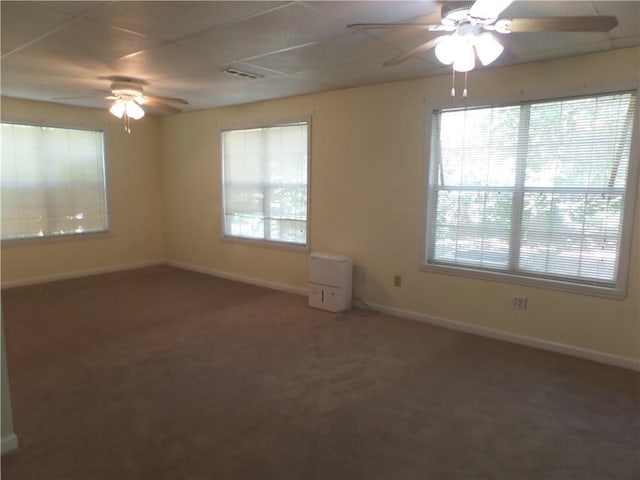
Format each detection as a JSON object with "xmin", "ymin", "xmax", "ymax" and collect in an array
[{"xmin": 309, "ymin": 253, "xmax": 353, "ymax": 312}]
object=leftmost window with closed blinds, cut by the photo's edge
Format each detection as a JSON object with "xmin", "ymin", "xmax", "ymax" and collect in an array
[{"xmin": 0, "ymin": 123, "xmax": 107, "ymax": 240}]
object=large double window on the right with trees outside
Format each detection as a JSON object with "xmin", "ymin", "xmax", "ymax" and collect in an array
[{"xmin": 424, "ymin": 92, "xmax": 636, "ymax": 296}]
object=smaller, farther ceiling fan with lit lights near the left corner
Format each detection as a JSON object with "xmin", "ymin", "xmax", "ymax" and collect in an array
[{"xmin": 104, "ymin": 78, "xmax": 189, "ymax": 133}]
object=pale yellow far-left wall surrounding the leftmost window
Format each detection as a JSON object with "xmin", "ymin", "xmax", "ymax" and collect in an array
[{"xmin": 2, "ymin": 98, "xmax": 164, "ymax": 284}]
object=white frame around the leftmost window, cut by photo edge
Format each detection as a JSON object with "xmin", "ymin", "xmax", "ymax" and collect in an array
[{"xmin": 0, "ymin": 118, "xmax": 112, "ymax": 247}]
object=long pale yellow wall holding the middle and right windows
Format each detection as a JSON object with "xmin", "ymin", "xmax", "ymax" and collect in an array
[{"xmin": 161, "ymin": 49, "xmax": 640, "ymax": 361}]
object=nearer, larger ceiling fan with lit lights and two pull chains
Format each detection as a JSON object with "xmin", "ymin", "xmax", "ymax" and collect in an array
[{"xmin": 347, "ymin": 0, "xmax": 618, "ymax": 96}]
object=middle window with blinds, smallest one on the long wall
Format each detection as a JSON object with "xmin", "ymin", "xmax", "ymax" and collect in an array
[{"xmin": 222, "ymin": 122, "xmax": 308, "ymax": 246}]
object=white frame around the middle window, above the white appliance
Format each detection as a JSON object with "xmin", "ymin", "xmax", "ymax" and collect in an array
[{"xmin": 218, "ymin": 115, "xmax": 312, "ymax": 253}]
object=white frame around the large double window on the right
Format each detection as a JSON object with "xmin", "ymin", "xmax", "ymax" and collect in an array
[{"xmin": 418, "ymin": 83, "xmax": 640, "ymax": 299}]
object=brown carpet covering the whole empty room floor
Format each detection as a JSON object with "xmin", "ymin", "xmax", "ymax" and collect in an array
[{"xmin": 2, "ymin": 267, "xmax": 640, "ymax": 480}]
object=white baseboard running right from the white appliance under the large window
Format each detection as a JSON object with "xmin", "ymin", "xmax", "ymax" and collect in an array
[{"xmin": 368, "ymin": 304, "xmax": 640, "ymax": 371}]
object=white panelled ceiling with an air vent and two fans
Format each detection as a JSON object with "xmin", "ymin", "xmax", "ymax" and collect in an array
[{"xmin": 0, "ymin": 0, "xmax": 640, "ymax": 113}]
